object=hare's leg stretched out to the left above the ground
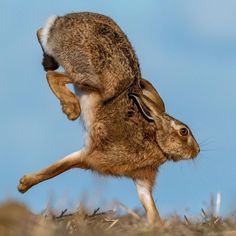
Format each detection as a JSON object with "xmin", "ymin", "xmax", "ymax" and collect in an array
[{"xmin": 18, "ymin": 150, "xmax": 89, "ymax": 193}]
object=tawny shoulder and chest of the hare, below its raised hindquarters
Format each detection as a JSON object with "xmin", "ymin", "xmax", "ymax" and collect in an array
[{"xmin": 79, "ymin": 88, "xmax": 166, "ymax": 181}]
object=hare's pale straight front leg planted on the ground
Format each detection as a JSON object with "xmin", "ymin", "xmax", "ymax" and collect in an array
[{"xmin": 135, "ymin": 180, "xmax": 163, "ymax": 225}]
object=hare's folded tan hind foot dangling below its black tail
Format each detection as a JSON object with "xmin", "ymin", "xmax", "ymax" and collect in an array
[{"xmin": 47, "ymin": 71, "xmax": 80, "ymax": 120}]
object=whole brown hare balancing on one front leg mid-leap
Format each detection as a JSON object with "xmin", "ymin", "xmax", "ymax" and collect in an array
[{"xmin": 18, "ymin": 13, "xmax": 200, "ymax": 224}]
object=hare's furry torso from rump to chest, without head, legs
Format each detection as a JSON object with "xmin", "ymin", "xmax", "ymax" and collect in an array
[{"xmin": 39, "ymin": 13, "xmax": 165, "ymax": 177}]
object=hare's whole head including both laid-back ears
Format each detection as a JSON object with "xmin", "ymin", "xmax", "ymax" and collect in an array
[{"xmin": 130, "ymin": 80, "xmax": 200, "ymax": 161}]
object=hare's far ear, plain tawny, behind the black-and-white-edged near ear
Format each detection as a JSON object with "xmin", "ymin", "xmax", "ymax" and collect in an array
[{"xmin": 140, "ymin": 79, "xmax": 165, "ymax": 112}]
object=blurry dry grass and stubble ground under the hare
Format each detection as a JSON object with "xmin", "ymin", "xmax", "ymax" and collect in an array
[{"xmin": 0, "ymin": 202, "xmax": 236, "ymax": 236}]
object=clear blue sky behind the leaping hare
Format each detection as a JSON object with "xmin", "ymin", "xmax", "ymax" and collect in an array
[{"xmin": 0, "ymin": 0, "xmax": 236, "ymax": 218}]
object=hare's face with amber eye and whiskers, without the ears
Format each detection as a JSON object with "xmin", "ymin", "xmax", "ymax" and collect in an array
[{"xmin": 156, "ymin": 114, "xmax": 200, "ymax": 161}]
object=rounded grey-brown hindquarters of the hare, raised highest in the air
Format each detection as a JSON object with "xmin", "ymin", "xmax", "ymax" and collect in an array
[{"xmin": 48, "ymin": 13, "xmax": 141, "ymax": 96}]
